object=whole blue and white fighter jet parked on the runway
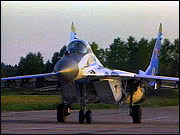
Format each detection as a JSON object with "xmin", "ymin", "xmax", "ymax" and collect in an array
[{"xmin": 1, "ymin": 23, "xmax": 179, "ymax": 124}]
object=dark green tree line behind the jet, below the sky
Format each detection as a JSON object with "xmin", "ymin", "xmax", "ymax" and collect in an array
[{"xmin": 1, "ymin": 36, "xmax": 179, "ymax": 77}]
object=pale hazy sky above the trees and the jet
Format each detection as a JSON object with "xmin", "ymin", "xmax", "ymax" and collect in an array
[{"xmin": 1, "ymin": 1, "xmax": 179, "ymax": 65}]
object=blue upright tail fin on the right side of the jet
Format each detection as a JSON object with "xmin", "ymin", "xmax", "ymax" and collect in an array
[{"xmin": 144, "ymin": 23, "xmax": 162, "ymax": 75}]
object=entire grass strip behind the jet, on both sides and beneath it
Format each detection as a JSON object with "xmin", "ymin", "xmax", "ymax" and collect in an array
[{"xmin": 1, "ymin": 88, "xmax": 179, "ymax": 112}]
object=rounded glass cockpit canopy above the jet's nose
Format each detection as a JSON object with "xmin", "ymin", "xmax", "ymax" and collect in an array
[{"xmin": 68, "ymin": 41, "xmax": 87, "ymax": 53}]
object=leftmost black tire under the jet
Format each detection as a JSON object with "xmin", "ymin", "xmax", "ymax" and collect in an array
[{"xmin": 57, "ymin": 104, "xmax": 66, "ymax": 122}]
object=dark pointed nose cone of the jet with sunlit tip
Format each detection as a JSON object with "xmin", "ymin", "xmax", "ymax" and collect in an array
[{"xmin": 54, "ymin": 56, "xmax": 79, "ymax": 81}]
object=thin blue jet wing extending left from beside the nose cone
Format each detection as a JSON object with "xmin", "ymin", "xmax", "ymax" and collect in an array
[{"xmin": 1, "ymin": 72, "xmax": 58, "ymax": 81}]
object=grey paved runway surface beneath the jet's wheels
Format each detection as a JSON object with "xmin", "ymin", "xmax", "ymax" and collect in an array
[{"xmin": 1, "ymin": 106, "xmax": 179, "ymax": 134}]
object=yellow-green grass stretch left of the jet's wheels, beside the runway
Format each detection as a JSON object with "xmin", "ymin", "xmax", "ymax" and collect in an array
[{"xmin": 1, "ymin": 95, "xmax": 61, "ymax": 111}]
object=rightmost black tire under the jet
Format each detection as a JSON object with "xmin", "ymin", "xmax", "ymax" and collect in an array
[{"xmin": 132, "ymin": 105, "xmax": 142, "ymax": 124}]
